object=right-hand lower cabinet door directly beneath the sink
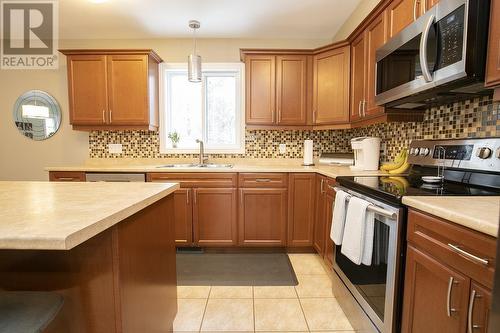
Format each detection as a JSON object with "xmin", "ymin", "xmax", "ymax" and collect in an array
[{"xmin": 193, "ymin": 188, "xmax": 237, "ymax": 246}]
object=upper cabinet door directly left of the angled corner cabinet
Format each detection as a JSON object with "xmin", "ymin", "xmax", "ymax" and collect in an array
[{"xmin": 276, "ymin": 55, "xmax": 307, "ymax": 125}]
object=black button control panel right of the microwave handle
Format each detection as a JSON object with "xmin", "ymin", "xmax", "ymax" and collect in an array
[{"xmin": 437, "ymin": 5, "xmax": 465, "ymax": 68}]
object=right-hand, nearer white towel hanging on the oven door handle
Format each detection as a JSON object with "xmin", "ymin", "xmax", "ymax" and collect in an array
[{"xmin": 340, "ymin": 197, "xmax": 373, "ymax": 265}]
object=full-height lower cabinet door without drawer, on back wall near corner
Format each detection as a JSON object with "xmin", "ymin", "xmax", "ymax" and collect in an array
[{"xmin": 287, "ymin": 173, "xmax": 316, "ymax": 247}]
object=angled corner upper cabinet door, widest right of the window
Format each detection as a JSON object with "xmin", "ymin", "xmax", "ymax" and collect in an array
[{"xmin": 313, "ymin": 46, "xmax": 350, "ymax": 125}]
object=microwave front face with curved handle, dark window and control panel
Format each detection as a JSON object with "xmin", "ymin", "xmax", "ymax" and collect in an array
[{"xmin": 375, "ymin": 0, "xmax": 468, "ymax": 109}]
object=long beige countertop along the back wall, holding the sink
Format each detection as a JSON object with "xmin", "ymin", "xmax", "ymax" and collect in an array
[{"xmin": 45, "ymin": 159, "xmax": 387, "ymax": 178}]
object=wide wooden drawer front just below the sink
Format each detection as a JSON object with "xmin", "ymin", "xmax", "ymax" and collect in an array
[{"xmin": 146, "ymin": 172, "xmax": 238, "ymax": 188}]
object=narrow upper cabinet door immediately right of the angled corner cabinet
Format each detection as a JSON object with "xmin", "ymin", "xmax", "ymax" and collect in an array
[{"xmin": 350, "ymin": 34, "xmax": 366, "ymax": 121}]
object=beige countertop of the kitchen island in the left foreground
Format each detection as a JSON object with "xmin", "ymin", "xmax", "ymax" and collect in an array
[{"xmin": 0, "ymin": 181, "xmax": 179, "ymax": 250}]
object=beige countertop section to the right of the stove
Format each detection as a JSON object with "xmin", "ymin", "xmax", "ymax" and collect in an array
[{"xmin": 403, "ymin": 196, "xmax": 500, "ymax": 237}]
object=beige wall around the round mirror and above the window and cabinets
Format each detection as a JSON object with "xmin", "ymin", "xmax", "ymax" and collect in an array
[{"xmin": 0, "ymin": 39, "xmax": 329, "ymax": 180}]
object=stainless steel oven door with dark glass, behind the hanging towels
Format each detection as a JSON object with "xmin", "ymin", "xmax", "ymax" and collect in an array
[{"xmin": 333, "ymin": 188, "xmax": 404, "ymax": 333}]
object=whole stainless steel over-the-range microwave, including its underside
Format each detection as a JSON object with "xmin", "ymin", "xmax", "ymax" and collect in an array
[{"xmin": 375, "ymin": 0, "xmax": 490, "ymax": 109}]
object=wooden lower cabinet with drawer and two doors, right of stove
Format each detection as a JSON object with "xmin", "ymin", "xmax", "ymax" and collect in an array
[{"xmin": 402, "ymin": 209, "xmax": 496, "ymax": 333}]
